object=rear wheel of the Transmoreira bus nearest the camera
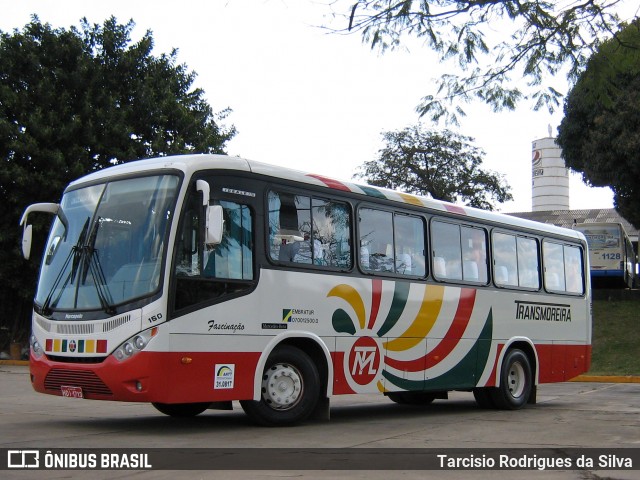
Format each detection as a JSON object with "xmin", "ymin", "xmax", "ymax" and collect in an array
[{"xmin": 491, "ymin": 348, "xmax": 533, "ymax": 410}]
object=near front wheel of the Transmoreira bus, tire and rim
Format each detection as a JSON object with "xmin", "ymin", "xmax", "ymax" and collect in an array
[{"xmin": 240, "ymin": 345, "xmax": 320, "ymax": 427}]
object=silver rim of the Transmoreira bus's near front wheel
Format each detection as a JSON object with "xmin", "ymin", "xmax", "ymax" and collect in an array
[{"xmin": 262, "ymin": 363, "xmax": 303, "ymax": 410}]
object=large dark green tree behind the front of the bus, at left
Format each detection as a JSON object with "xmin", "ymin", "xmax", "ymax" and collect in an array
[{"xmin": 0, "ymin": 16, "xmax": 235, "ymax": 348}]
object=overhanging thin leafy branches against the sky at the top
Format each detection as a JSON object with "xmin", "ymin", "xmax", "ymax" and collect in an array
[{"xmin": 334, "ymin": 0, "xmax": 619, "ymax": 124}]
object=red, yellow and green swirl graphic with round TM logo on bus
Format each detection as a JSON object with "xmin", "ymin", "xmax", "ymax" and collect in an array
[{"xmin": 327, "ymin": 279, "xmax": 493, "ymax": 392}]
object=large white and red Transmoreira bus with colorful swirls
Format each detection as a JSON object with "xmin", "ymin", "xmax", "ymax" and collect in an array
[{"xmin": 21, "ymin": 154, "xmax": 591, "ymax": 426}]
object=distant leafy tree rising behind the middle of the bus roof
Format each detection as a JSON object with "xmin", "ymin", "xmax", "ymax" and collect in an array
[{"xmin": 355, "ymin": 125, "xmax": 512, "ymax": 210}]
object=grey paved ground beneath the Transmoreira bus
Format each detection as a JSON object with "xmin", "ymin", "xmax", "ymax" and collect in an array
[{"xmin": 0, "ymin": 365, "xmax": 640, "ymax": 480}]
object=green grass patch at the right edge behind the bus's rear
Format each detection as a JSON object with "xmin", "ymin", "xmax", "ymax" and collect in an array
[{"xmin": 588, "ymin": 300, "xmax": 640, "ymax": 375}]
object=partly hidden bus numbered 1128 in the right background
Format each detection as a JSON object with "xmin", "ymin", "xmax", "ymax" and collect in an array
[{"xmin": 574, "ymin": 223, "xmax": 637, "ymax": 288}]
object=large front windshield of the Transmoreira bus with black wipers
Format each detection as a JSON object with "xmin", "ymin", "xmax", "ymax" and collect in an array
[{"xmin": 35, "ymin": 175, "xmax": 179, "ymax": 314}]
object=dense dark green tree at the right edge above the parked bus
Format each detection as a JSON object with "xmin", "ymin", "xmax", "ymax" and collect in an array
[{"xmin": 556, "ymin": 19, "xmax": 640, "ymax": 226}]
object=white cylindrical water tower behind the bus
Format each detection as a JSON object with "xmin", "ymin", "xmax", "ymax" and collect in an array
[{"xmin": 531, "ymin": 127, "xmax": 569, "ymax": 212}]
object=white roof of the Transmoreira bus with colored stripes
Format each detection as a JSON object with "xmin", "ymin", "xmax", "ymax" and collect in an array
[{"xmin": 68, "ymin": 154, "xmax": 584, "ymax": 240}]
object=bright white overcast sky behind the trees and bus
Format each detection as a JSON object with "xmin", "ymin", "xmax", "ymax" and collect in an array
[{"xmin": 0, "ymin": 0, "xmax": 638, "ymax": 212}]
